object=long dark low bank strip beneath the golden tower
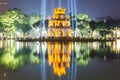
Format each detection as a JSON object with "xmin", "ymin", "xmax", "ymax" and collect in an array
[{"xmin": 16, "ymin": 38, "xmax": 116, "ymax": 42}]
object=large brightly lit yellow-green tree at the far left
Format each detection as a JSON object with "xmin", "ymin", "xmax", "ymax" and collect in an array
[{"xmin": 0, "ymin": 8, "xmax": 26, "ymax": 35}]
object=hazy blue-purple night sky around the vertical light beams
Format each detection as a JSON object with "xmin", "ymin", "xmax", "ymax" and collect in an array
[{"xmin": 8, "ymin": 0, "xmax": 120, "ymax": 19}]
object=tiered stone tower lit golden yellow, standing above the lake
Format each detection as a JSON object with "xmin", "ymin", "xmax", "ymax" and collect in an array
[{"xmin": 48, "ymin": 7, "xmax": 71, "ymax": 38}]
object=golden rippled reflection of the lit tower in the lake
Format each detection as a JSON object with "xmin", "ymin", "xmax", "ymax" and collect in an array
[{"xmin": 48, "ymin": 42, "xmax": 72, "ymax": 76}]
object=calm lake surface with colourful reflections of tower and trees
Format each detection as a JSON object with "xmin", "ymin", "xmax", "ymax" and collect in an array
[{"xmin": 0, "ymin": 40, "xmax": 120, "ymax": 80}]
